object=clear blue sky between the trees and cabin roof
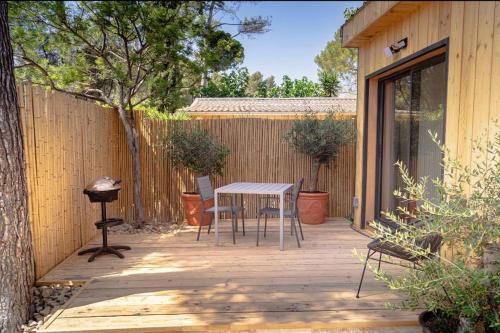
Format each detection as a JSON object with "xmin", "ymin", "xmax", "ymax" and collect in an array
[{"xmin": 221, "ymin": 1, "xmax": 362, "ymax": 83}]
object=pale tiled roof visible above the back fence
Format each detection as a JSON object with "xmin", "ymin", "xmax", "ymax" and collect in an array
[{"xmin": 185, "ymin": 97, "xmax": 356, "ymax": 114}]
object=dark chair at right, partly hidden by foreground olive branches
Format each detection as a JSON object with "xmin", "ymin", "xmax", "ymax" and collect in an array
[{"xmin": 356, "ymin": 230, "xmax": 443, "ymax": 298}]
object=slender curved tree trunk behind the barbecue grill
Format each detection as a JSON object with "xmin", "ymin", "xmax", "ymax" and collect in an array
[{"xmin": 118, "ymin": 106, "xmax": 144, "ymax": 228}]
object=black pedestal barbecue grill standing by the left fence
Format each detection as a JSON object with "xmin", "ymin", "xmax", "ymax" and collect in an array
[{"xmin": 78, "ymin": 177, "xmax": 130, "ymax": 262}]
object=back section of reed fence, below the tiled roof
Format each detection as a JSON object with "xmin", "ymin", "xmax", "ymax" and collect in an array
[{"xmin": 114, "ymin": 114, "xmax": 355, "ymax": 222}]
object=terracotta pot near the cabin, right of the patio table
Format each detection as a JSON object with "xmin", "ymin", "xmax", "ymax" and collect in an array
[{"xmin": 297, "ymin": 192, "xmax": 328, "ymax": 224}]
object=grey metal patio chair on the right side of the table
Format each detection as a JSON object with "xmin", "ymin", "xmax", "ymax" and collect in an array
[{"xmin": 257, "ymin": 178, "xmax": 304, "ymax": 247}]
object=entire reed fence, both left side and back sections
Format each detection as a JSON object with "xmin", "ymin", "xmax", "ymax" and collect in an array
[{"xmin": 18, "ymin": 85, "xmax": 355, "ymax": 278}]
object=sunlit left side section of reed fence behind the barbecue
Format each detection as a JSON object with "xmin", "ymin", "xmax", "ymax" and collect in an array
[{"xmin": 18, "ymin": 85, "xmax": 118, "ymax": 278}]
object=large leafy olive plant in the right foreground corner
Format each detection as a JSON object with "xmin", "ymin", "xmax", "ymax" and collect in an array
[{"xmin": 364, "ymin": 132, "xmax": 500, "ymax": 333}]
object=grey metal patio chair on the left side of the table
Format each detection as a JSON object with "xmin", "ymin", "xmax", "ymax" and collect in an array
[{"xmin": 196, "ymin": 176, "xmax": 245, "ymax": 244}]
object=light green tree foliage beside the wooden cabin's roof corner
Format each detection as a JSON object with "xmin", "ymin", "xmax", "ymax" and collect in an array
[{"xmin": 314, "ymin": 30, "xmax": 358, "ymax": 91}]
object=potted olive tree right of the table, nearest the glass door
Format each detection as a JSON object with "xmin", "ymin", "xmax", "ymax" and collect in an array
[{"xmin": 285, "ymin": 112, "xmax": 354, "ymax": 224}]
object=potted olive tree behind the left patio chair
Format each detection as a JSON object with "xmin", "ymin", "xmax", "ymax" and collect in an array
[{"xmin": 163, "ymin": 126, "xmax": 229, "ymax": 225}]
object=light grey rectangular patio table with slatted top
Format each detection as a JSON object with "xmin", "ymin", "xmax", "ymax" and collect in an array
[{"xmin": 214, "ymin": 183, "xmax": 293, "ymax": 251}]
